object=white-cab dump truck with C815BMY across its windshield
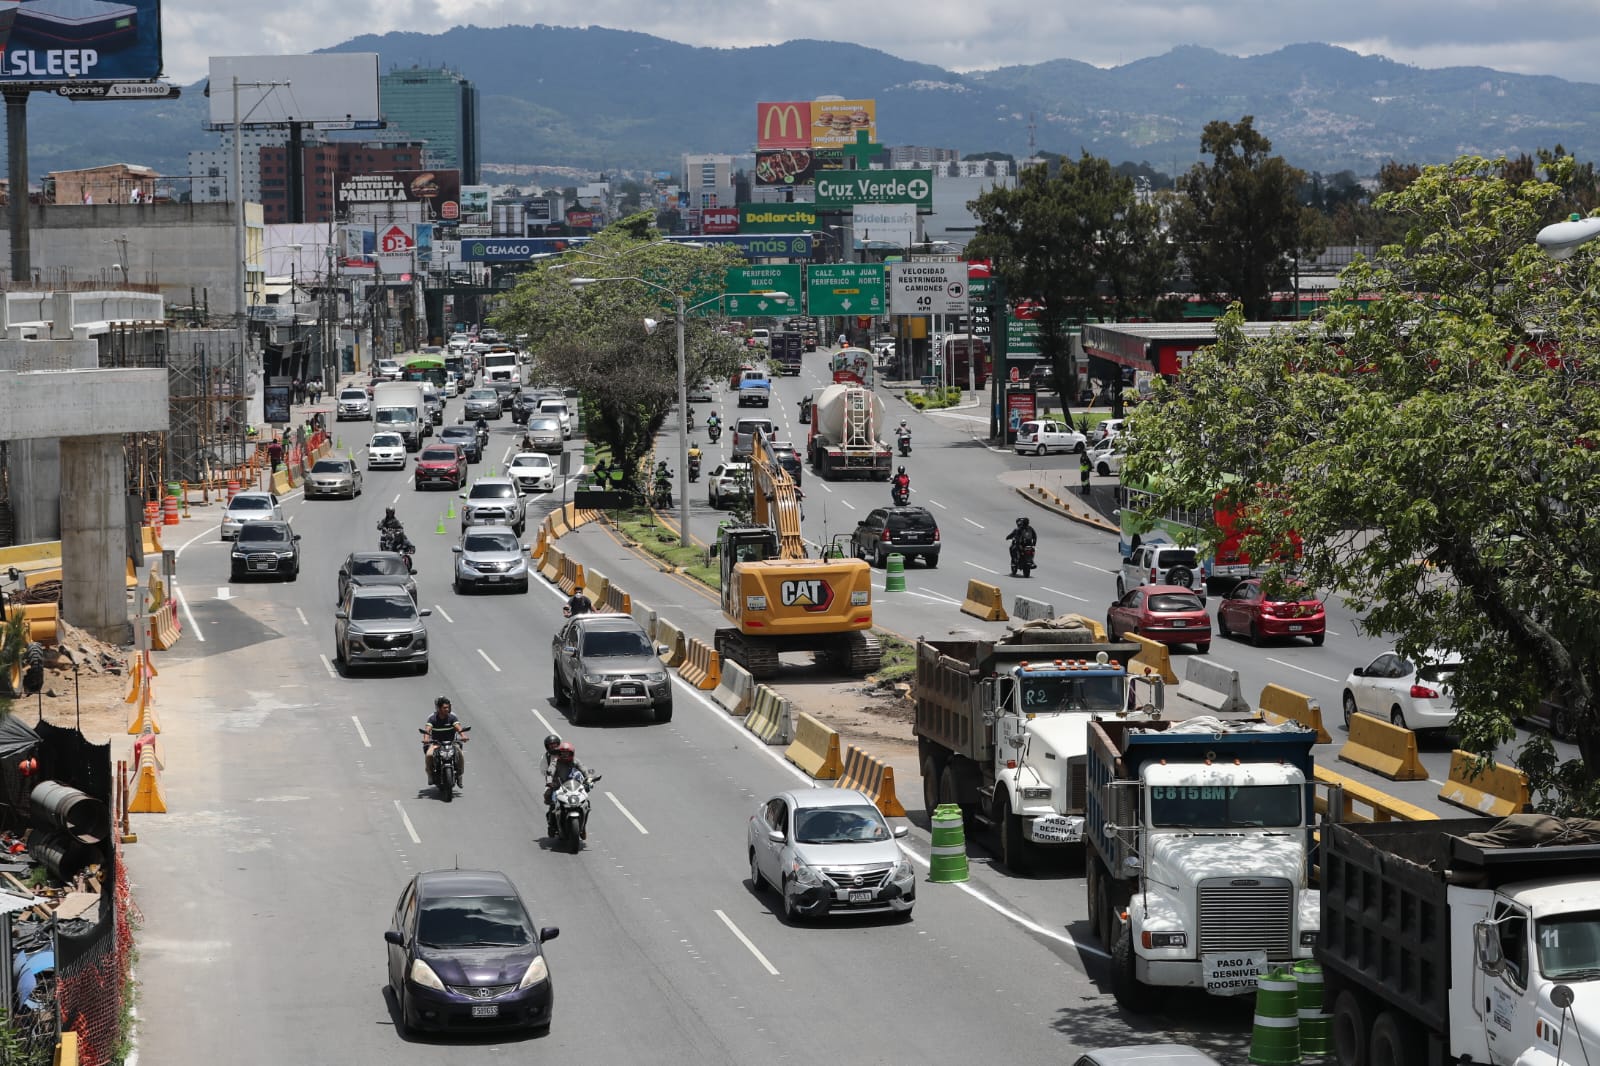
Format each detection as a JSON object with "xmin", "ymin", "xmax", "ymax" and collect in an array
[{"xmin": 1083, "ymin": 717, "xmax": 1324, "ymax": 1005}]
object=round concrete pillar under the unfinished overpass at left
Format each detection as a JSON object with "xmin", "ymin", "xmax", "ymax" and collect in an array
[{"xmin": 61, "ymin": 434, "xmax": 130, "ymax": 643}]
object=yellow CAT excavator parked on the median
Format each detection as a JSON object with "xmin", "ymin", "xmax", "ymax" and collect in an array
[{"xmin": 715, "ymin": 432, "xmax": 883, "ymax": 680}]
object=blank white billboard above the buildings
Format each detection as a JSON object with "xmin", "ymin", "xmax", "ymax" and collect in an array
[{"xmin": 206, "ymin": 51, "xmax": 377, "ymax": 124}]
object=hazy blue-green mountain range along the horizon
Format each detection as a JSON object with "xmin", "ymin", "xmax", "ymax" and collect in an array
[{"xmin": 12, "ymin": 26, "xmax": 1600, "ymax": 179}]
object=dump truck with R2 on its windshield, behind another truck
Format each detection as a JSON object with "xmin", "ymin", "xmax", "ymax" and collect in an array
[{"xmin": 912, "ymin": 626, "xmax": 1162, "ymax": 874}]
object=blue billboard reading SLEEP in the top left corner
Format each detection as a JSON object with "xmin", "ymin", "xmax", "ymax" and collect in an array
[{"xmin": 0, "ymin": 0, "xmax": 162, "ymax": 85}]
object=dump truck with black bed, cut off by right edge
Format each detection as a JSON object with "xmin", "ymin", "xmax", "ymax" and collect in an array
[{"xmin": 1317, "ymin": 815, "xmax": 1600, "ymax": 1066}]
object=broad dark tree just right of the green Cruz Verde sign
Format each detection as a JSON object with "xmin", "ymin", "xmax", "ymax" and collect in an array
[{"xmin": 966, "ymin": 152, "xmax": 1171, "ymax": 408}]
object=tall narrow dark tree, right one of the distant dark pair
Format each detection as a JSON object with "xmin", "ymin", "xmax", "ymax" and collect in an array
[{"xmin": 1171, "ymin": 115, "xmax": 1325, "ymax": 319}]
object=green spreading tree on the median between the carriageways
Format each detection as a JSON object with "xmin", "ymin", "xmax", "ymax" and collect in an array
[{"xmin": 494, "ymin": 227, "xmax": 741, "ymax": 483}]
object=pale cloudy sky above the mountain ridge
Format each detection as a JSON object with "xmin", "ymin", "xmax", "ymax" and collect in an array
[{"xmin": 162, "ymin": 0, "xmax": 1600, "ymax": 83}]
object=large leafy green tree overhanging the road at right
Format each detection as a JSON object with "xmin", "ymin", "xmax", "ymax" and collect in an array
[{"xmin": 1128, "ymin": 157, "xmax": 1600, "ymax": 815}]
